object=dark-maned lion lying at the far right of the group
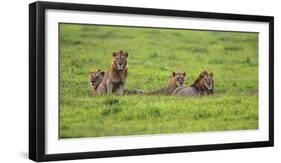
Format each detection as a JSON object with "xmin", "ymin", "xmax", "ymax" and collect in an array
[{"xmin": 172, "ymin": 71, "xmax": 214, "ymax": 96}]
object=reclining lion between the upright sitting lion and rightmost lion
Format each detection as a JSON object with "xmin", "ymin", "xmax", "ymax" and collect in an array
[{"xmin": 146, "ymin": 72, "xmax": 185, "ymax": 95}]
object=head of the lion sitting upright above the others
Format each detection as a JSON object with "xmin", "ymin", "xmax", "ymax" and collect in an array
[{"xmin": 112, "ymin": 50, "xmax": 128, "ymax": 70}]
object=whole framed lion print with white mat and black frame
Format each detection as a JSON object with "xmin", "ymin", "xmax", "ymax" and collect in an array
[{"xmin": 29, "ymin": 2, "xmax": 274, "ymax": 161}]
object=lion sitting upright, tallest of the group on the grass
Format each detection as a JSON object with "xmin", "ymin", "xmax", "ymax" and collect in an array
[{"xmin": 96, "ymin": 50, "xmax": 128, "ymax": 95}]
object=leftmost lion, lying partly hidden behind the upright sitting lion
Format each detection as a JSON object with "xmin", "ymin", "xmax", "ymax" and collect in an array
[{"xmin": 89, "ymin": 69, "xmax": 143, "ymax": 95}]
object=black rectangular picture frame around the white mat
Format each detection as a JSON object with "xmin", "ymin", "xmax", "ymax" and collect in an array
[{"xmin": 29, "ymin": 2, "xmax": 274, "ymax": 161}]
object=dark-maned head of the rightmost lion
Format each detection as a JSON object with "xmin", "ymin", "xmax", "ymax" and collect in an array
[{"xmin": 194, "ymin": 71, "xmax": 214, "ymax": 93}]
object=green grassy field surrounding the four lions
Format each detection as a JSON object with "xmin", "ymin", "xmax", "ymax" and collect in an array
[{"xmin": 60, "ymin": 24, "xmax": 258, "ymax": 138}]
